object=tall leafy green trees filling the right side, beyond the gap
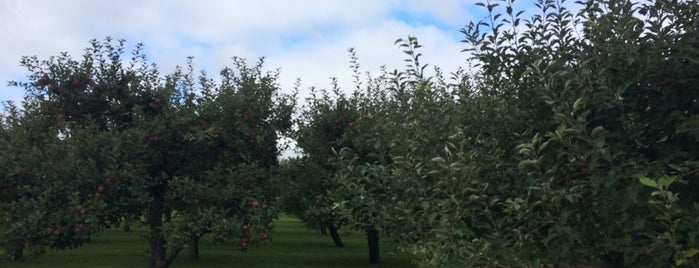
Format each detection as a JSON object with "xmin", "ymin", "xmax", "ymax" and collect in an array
[{"xmin": 290, "ymin": 0, "xmax": 699, "ymax": 267}]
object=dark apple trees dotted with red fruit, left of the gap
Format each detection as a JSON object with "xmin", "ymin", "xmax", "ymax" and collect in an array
[{"xmin": 0, "ymin": 38, "xmax": 295, "ymax": 267}]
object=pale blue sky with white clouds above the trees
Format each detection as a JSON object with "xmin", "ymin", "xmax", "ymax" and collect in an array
[{"xmin": 0, "ymin": 0, "xmax": 500, "ymax": 104}]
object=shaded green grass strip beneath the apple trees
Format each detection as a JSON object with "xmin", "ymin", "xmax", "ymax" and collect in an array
[{"xmin": 0, "ymin": 216, "xmax": 412, "ymax": 268}]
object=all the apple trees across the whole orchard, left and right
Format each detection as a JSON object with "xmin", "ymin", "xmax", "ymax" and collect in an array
[{"xmin": 0, "ymin": 0, "xmax": 699, "ymax": 267}]
